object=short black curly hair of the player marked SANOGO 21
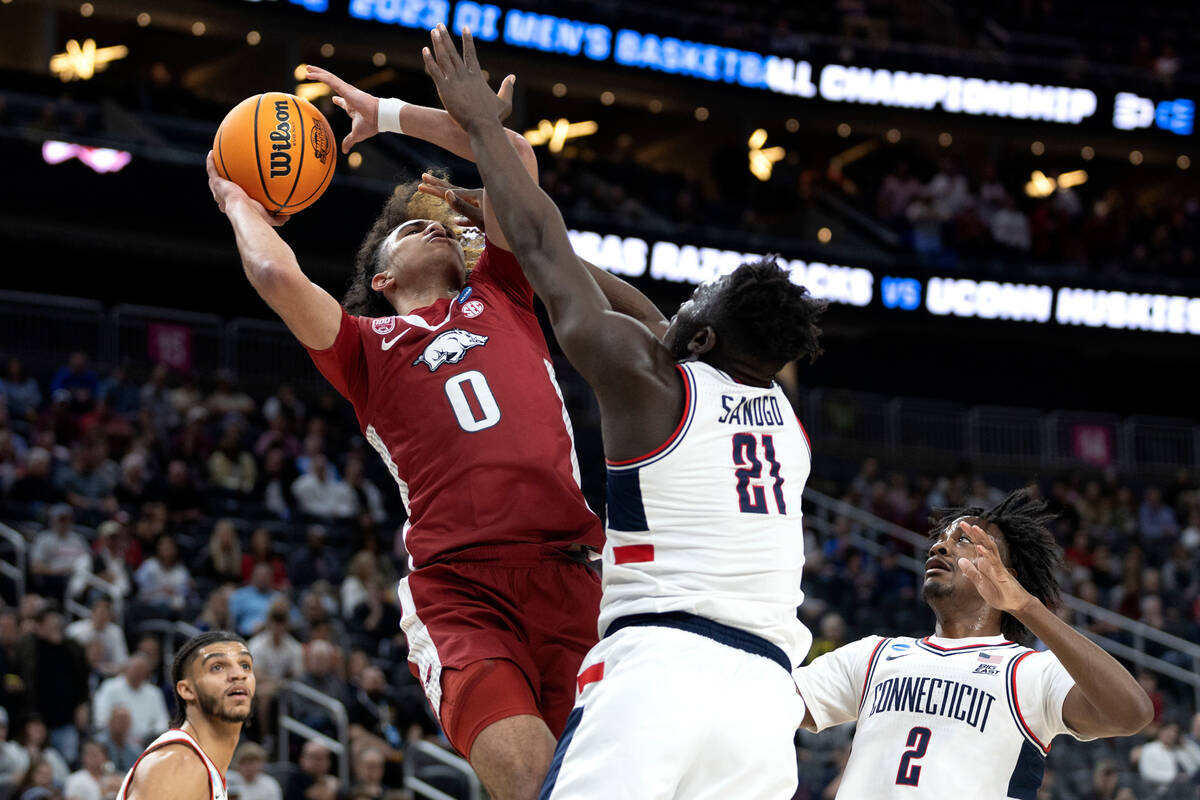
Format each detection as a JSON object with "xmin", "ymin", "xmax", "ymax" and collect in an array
[{"xmin": 720, "ymin": 255, "xmax": 829, "ymax": 367}]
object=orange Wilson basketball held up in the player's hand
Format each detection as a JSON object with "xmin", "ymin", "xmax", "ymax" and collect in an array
[{"xmin": 212, "ymin": 91, "xmax": 337, "ymax": 213}]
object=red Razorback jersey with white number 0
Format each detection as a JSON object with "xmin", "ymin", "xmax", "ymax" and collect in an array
[{"xmin": 308, "ymin": 242, "xmax": 604, "ymax": 567}]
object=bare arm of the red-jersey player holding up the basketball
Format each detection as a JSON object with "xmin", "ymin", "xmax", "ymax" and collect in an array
[{"xmin": 208, "ymin": 151, "xmax": 342, "ymax": 350}]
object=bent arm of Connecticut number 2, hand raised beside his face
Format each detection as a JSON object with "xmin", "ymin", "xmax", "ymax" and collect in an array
[{"xmin": 959, "ymin": 523, "xmax": 1154, "ymax": 736}]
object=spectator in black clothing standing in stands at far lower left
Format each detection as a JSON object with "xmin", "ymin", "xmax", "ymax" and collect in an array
[{"xmin": 17, "ymin": 603, "xmax": 88, "ymax": 762}]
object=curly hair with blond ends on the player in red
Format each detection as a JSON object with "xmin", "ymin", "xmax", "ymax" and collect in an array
[{"xmin": 342, "ymin": 169, "xmax": 484, "ymax": 317}]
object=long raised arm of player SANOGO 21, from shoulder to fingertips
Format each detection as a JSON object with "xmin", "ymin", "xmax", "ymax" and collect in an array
[{"xmin": 422, "ymin": 25, "xmax": 677, "ymax": 393}]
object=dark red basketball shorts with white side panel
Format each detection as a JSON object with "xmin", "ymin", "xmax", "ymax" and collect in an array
[{"xmin": 400, "ymin": 545, "xmax": 600, "ymax": 758}]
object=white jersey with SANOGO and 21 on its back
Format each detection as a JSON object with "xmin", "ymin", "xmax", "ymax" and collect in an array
[{"xmin": 600, "ymin": 361, "xmax": 812, "ymax": 667}]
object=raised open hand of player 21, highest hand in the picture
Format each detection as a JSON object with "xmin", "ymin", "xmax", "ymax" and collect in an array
[{"xmin": 421, "ymin": 24, "xmax": 516, "ymax": 131}]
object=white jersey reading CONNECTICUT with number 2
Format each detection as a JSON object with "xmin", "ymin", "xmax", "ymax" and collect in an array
[{"xmin": 793, "ymin": 636, "xmax": 1082, "ymax": 800}]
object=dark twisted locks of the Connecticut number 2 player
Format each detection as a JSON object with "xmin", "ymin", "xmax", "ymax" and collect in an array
[{"xmin": 929, "ymin": 487, "xmax": 1062, "ymax": 644}]
